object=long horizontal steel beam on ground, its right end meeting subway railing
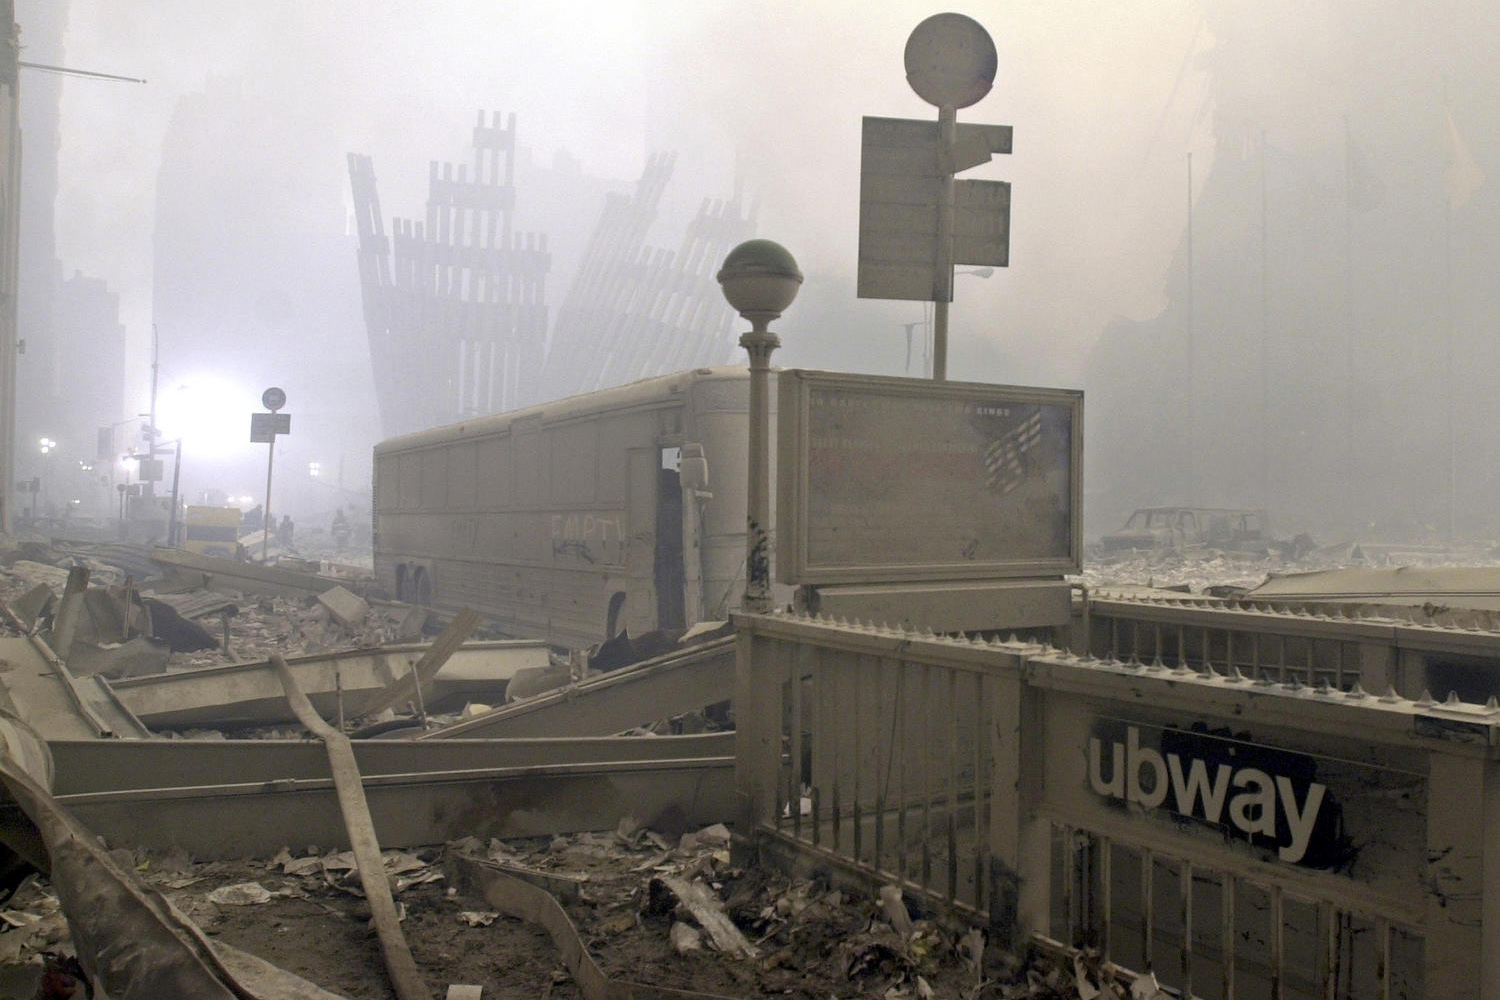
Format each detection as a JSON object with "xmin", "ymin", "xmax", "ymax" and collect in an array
[{"xmin": 53, "ymin": 736, "xmax": 734, "ymax": 859}]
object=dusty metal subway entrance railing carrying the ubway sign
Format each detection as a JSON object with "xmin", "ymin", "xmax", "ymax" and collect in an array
[{"xmin": 735, "ymin": 609, "xmax": 1500, "ymax": 1000}]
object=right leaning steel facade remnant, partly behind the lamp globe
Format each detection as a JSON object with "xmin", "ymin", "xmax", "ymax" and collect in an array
[{"xmin": 530, "ymin": 153, "xmax": 755, "ymax": 402}]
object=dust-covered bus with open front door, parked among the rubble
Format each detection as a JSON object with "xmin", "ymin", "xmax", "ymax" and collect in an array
[{"xmin": 375, "ymin": 367, "xmax": 774, "ymax": 646}]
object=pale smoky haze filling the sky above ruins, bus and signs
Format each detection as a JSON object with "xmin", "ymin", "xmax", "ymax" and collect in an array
[{"xmin": 17, "ymin": 0, "xmax": 1500, "ymax": 542}]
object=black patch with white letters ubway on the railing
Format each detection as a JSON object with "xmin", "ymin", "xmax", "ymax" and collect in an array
[{"xmin": 1088, "ymin": 720, "xmax": 1353, "ymax": 868}]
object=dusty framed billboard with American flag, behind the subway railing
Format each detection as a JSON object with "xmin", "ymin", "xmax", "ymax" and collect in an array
[{"xmin": 776, "ymin": 369, "xmax": 1083, "ymax": 586}]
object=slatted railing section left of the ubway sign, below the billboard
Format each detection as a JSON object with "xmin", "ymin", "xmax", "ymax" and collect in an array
[{"xmin": 773, "ymin": 632, "xmax": 995, "ymax": 912}]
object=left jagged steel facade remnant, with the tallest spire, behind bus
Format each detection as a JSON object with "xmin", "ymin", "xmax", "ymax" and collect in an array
[{"xmin": 350, "ymin": 111, "xmax": 551, "ymax": 435}]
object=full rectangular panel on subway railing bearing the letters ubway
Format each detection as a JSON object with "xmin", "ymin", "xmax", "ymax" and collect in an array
[{"xmin": 1044, "ymin": 699, "xmax": 1428, "ymax": 891}]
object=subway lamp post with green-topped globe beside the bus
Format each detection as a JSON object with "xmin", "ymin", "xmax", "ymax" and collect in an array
[{"xmin": 719, "ymin": 240, "xmax": 803, "ymax": 615}]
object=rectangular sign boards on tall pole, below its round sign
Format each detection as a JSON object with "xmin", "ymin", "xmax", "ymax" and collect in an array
[{"xmin": 858, "ymin": 117, "xmax": 1011, "ymax": 301}]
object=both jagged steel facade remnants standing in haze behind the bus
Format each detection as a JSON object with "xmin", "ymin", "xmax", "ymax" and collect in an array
[{"xmin": 348, "ymin": 112, "xmax": 755, "ymax": 436}]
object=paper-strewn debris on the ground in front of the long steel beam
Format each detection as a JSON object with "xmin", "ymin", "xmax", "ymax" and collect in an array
[{"xmin": 0, "ymin": 819, "xmax": 1146, "ymax": 1000}]
